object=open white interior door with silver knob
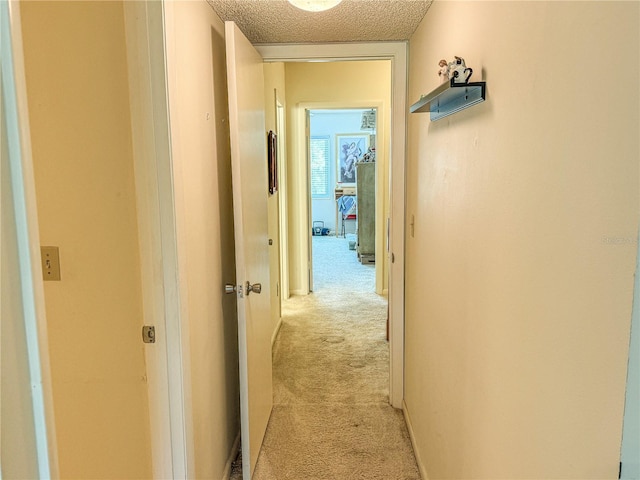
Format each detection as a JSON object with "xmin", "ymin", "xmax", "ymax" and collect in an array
[{"xmin": 225, "ymin": 22, "xmax": 273, "ymax": 480}]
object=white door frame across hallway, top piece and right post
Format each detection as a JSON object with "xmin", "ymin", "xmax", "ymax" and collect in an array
[{"xmin": 256, "ymin": 42, "xmax": 408, "ymax": 408}]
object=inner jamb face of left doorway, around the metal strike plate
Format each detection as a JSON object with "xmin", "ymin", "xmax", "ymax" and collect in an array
[{"xmin": 124, "ymin": 2, "xmax": 173, "ymax": 478}]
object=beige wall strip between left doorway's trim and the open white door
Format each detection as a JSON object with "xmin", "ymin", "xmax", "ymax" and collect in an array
[{"xmin": 166, "ymin": 0, "xmax": 240, "ymax": 478}]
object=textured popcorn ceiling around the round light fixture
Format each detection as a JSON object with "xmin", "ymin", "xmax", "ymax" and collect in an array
[{"xmin": 207, "ymin": 0, "xmax": 432, "ymax": 44}]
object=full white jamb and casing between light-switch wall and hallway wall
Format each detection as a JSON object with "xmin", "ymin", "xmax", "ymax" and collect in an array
[{"xmin": 125, "ymin": 2, "xmax": 193, "ymax": 478}]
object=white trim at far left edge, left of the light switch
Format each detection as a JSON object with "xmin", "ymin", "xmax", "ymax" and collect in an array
[{"xmin": 0, "ymin": 1, "xmax": 59, "ymax": 479}]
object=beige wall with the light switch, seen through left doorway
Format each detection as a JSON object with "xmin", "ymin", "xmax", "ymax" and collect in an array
[{"xmin": 21, "ymin": 1, "xmax": 151, "ymax": 478}]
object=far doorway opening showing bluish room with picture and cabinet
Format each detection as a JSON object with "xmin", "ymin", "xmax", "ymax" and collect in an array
[{"xmin": 307, "ymin": 106, "xmax": 378, "ymax": 293}]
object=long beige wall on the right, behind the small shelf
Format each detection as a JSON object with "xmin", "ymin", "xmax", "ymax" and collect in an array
[{"xmin": 405, "ymin": 1, "xmax": 640, "ymax": 479}]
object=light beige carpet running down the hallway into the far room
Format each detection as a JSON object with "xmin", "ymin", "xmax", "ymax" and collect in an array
[{"xmin": 232, "ymin": 236, "xmax": 420, "ymax": 480}]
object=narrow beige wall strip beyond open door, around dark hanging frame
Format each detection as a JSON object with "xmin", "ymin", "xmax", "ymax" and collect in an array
[{"xmin": 264, "ymin": 62, "xmax": 286, "ymax": 339}]
